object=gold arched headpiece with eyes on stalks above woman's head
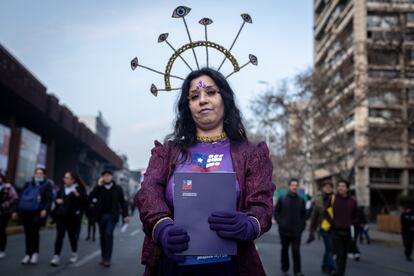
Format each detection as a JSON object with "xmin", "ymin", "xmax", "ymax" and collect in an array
[{"xmin": 131, "ymin": 6, "xmax": 257, "ymax": 96}]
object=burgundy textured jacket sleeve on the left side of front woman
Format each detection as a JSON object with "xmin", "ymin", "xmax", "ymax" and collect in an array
[{"xmin": 135, "ymin": 141, "xmax": 172, "ymax": 238}]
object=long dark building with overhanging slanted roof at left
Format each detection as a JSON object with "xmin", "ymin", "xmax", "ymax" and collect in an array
[{"xmin": 0, "ymin": 45, "xmax": 123, "ymax": 189}]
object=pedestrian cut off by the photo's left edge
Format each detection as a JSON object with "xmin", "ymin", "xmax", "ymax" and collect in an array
[{"xmin": 0, "ymin": 172, "xmax": 18, "ymax": 259}]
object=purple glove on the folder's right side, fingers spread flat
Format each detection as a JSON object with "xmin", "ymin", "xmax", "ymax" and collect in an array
[{"xmin": 208, "ymin": 211, "xmax": 259, "ymax": 241}]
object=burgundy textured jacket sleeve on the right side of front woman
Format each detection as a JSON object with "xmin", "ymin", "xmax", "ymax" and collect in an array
[{"xmin": 244, "ymin": 142, "xmax": 276, "ymax": 235}]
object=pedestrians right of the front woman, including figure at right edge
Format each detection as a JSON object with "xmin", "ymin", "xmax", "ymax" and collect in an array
[{"xmin": 274, "ymin": 179, "xmax": 414, "ymax": 276}]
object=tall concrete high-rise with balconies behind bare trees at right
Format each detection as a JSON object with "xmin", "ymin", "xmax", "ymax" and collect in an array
[{"xmin": 314, "ymin": 0, "xmax": 414, "ymax": 214}]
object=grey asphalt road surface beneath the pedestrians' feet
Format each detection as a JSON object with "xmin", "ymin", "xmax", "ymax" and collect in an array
[{"xmin": 0, "ymin": 217, "xmax": 414, "ymax": 276}]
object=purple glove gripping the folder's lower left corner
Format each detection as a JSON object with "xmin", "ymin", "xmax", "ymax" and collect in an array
[{"xmin": 154, "ymin": 220, "xmax": 190, "ymax": 262}]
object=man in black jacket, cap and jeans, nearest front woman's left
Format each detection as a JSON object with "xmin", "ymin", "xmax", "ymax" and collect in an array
[{"xmin": 90, "ymin": 170, "xmax": 129, "ymax": 267}]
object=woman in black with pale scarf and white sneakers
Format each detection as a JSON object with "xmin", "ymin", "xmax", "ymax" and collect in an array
[{"xmin": 50, "ymin": 172, "xmax": 88, "ymax": 266}]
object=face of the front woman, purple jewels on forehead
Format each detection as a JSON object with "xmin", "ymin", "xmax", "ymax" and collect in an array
[{"xmin": 188, "ymin": 75, "xmax": 224, "ymax": 131}]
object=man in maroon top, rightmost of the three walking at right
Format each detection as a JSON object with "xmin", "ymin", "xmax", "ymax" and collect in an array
[{"xmin": 331, "ymin": 179, "xmax": 357, "ymax": 276}]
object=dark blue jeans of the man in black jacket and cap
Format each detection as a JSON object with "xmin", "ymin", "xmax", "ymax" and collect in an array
[{"xmin": 99, "ymin": 214, "xmax": 116, "ymax": 262}]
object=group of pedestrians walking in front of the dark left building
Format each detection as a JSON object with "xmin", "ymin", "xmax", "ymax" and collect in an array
[{"xmin": 0, "ymin": 168, "xmax": 129, "ymax": 267}]
